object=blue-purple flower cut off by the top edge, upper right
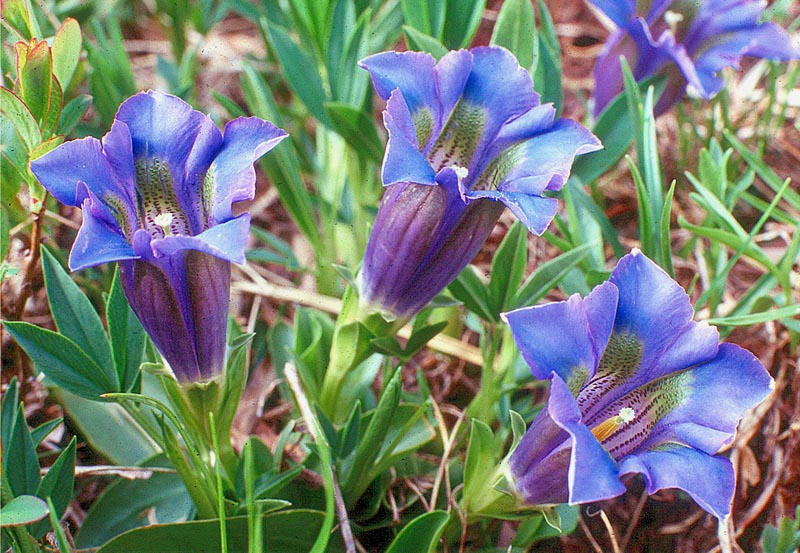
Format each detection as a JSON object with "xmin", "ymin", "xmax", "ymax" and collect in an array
[{"xmin": 590, "ymin": 0, "xmax": 800, "ymax": 116}]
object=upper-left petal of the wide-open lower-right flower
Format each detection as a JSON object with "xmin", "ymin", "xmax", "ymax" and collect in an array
[{"xmin": 503, "ymin": 283, "xmax": 619, "ymax": 387}]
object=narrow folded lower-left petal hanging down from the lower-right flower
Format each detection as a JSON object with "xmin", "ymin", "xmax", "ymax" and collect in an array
[{"xmin": 547, "ymin": 375, "xmax": 625, "ymax": 505}]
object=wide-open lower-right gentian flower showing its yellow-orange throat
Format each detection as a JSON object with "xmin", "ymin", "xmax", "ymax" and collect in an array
[{"xmin": 504, "ymin": 251, "xmax": 773, "ymax": 519}]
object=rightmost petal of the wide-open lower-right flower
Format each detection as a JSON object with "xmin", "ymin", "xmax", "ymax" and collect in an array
[{"xmin": 642, "ymin": 344, "xmax": 774, "ymax": 455}]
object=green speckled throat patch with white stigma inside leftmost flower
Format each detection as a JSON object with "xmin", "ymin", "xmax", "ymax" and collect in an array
[{"xmin": 136, "ymin": 158, "xmax": 192, "ymax": 238}]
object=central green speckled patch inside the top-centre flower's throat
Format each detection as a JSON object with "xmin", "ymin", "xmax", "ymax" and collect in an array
[{"xmin": 428, "ymin": 102, "xmax": 486, "ymax": 172}]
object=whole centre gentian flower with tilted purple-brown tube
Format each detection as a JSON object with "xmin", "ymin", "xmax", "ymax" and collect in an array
[{"xmin": 359, "ymin": 47, "xmax": 600, "ymax": 322}]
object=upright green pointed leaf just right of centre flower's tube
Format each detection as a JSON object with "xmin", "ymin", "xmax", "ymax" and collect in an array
[{"xmin": 489, "ymin": 221, "xmax": 528, "ymax": 317}]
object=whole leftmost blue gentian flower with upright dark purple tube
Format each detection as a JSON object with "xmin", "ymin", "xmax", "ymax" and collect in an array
[{"xmin": 31, "ymin": 91, "xmax": 286, "ymax": 382}]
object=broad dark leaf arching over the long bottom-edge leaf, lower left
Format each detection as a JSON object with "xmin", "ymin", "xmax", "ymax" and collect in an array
[{"xmin": 75, "ymin": 456, "xmax": 197, "ymax": 551}]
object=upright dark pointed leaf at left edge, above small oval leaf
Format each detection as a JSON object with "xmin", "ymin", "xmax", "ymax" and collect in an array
[{"xmin": 3, "ymin": 403, "xmax": 41, "ymax": 496}]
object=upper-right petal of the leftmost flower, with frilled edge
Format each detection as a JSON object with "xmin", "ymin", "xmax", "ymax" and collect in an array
[{"xmin": 206, "ymin": 117, "xmax": 287, "ymax": 225}]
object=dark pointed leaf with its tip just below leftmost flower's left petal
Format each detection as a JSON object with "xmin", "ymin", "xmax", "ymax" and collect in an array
[{"xmin": 42, "ymin": 246, "xmax": 114, "ymax": 380}]
